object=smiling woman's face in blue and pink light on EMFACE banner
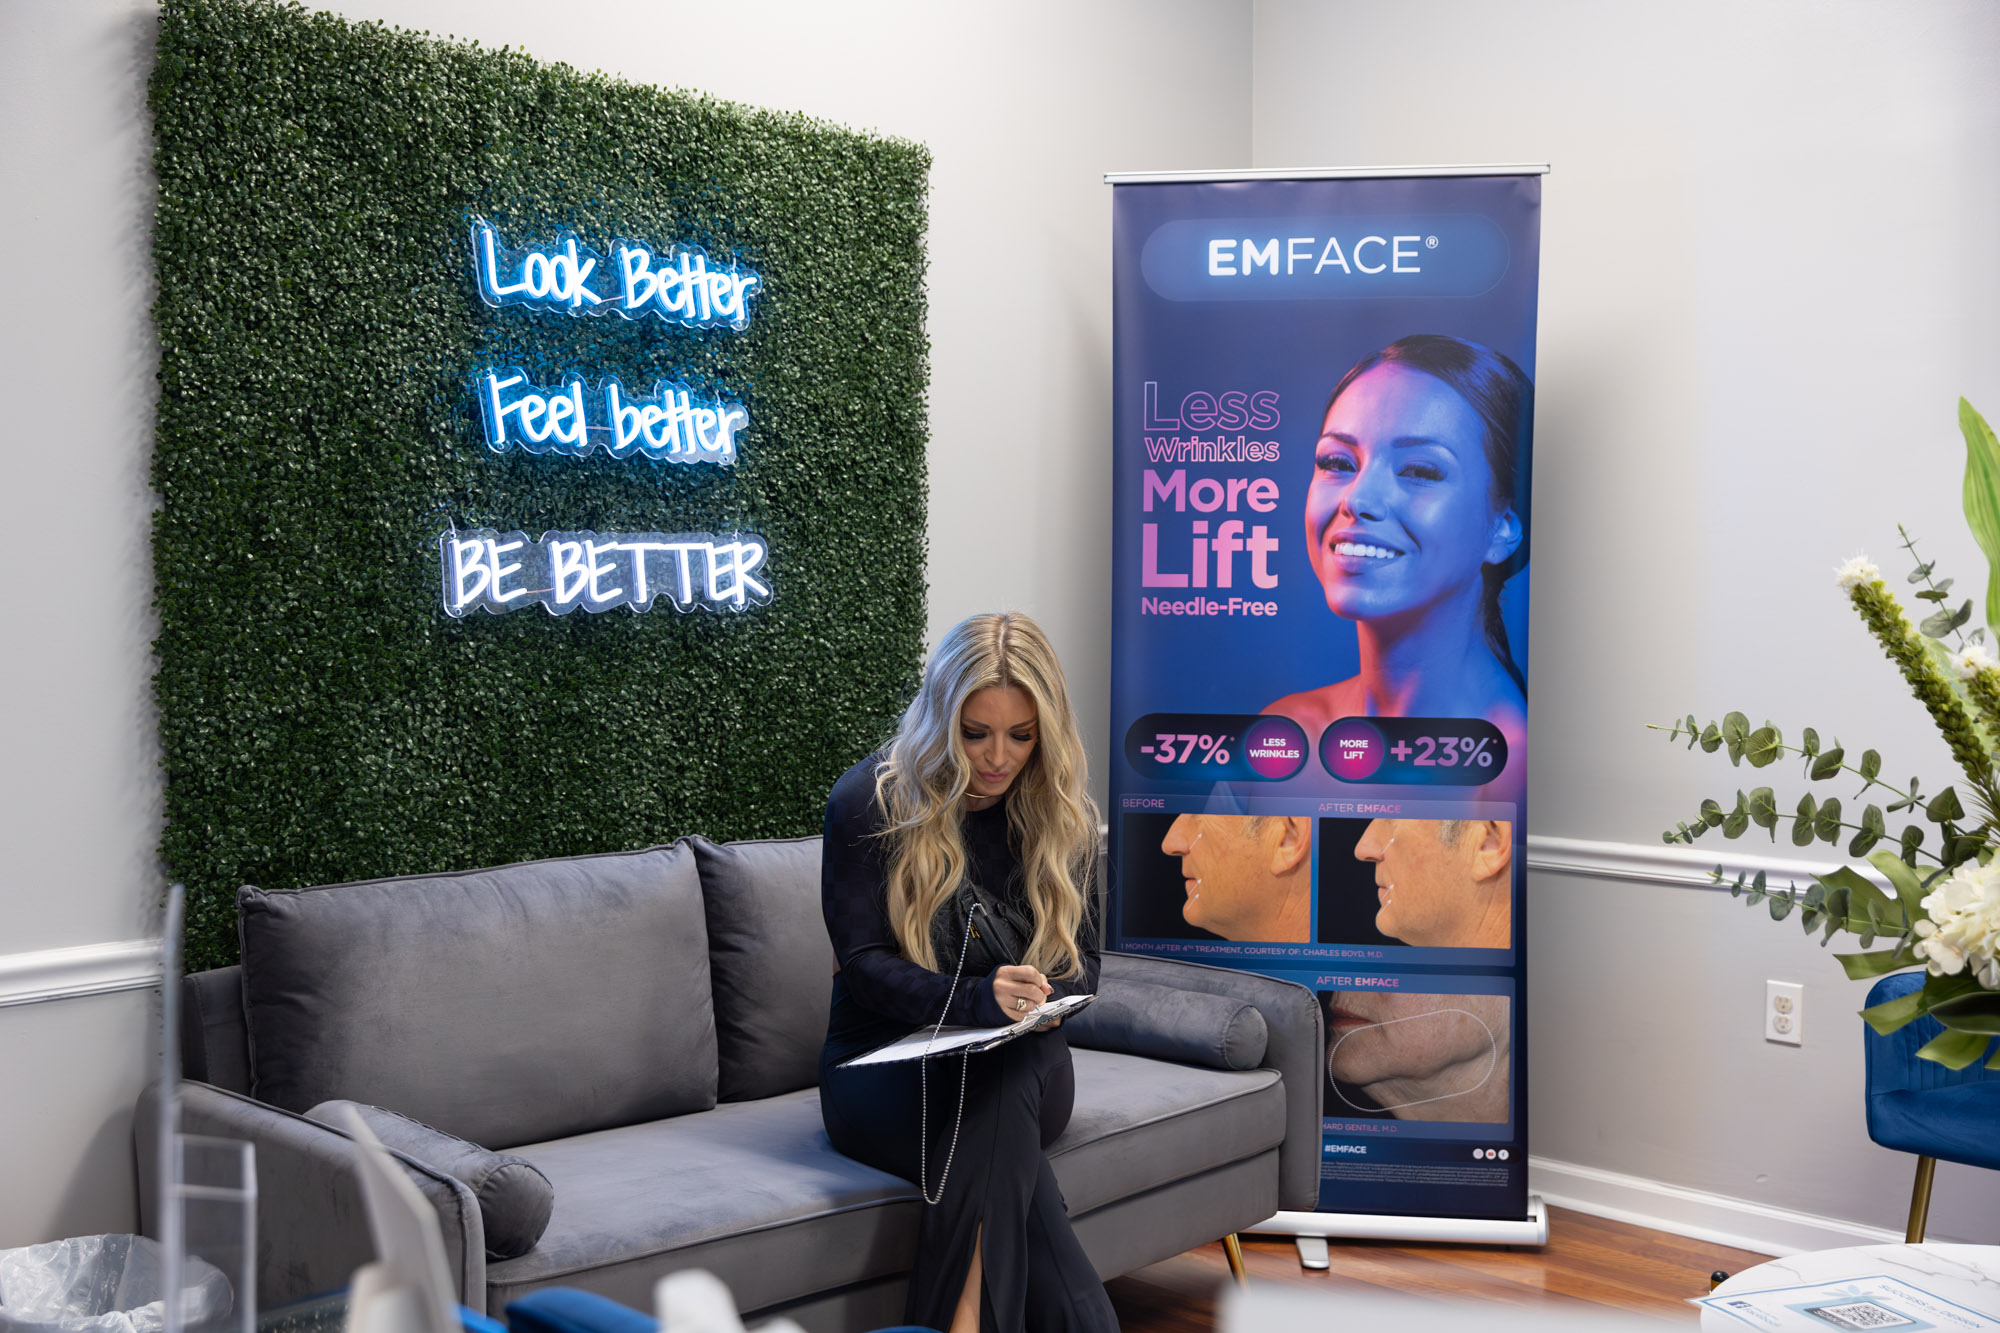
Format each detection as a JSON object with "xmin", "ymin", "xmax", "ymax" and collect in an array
[{"xmin": 1306, "ymin": 362, "xmax": 1506, "ymax": 620}]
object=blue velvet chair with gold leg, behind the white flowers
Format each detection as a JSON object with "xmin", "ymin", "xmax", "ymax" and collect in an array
[{"xmin": 1862, "ymin": 973, "xmax": 2000, "ymax": 1245}]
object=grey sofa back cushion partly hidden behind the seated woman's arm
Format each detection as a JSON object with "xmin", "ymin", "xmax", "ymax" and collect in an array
[{"xmin": 688, "ymin": 837, "xmax": 834, "ymax": 1101}]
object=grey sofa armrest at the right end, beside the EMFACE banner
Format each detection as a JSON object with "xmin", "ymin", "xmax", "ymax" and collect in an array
[{"xmin": 1086, "ymin": 953, "xmax": 1326, "ymax": 1211}]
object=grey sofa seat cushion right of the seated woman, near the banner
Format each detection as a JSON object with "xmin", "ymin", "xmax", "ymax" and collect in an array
[{"xmin": 1048, "ymin": 1049, "xmax": 1284, "ymax": 1217}]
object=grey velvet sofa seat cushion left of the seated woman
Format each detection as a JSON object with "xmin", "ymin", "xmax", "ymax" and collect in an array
[{"xmin": 486, "ymin": 1089, "xmax": 922, "ymax": 1311}]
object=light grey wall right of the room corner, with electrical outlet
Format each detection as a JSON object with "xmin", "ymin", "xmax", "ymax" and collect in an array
[{"xmin": 1252, "ymin": 0, "xmax": 2000, "ymax": 1241}]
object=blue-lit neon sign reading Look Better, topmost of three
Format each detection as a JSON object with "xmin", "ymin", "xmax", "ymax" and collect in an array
[{"xmin": 472, "ymin": 218, "xmax": 762, "ymax": 328}]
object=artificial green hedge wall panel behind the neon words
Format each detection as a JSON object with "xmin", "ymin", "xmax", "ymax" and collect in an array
[{"xmin": 152, "ymin": 0, "xmax": 930, "ymax": 969}]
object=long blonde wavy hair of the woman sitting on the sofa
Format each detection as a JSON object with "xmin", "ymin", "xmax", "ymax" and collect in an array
[{"xmin": 876, "ymin": 612, "xmax": 1098, "ymax": 977}]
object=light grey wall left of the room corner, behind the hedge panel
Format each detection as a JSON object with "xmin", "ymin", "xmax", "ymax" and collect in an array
[{"xmin": 0, "ymin": 0, "xmax": 1250, "ymax": 1247}]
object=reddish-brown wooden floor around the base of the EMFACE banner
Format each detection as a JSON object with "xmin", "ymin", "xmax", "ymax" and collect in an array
[{"xmin": 1108, "ymin": 1209, "xmax": 1768, "ymax": 1333}]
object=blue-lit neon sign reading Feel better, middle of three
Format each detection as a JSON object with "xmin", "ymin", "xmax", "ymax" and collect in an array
[{"xmin": 478, "ymin": 368, "xmax": 750, "ymax": 466}]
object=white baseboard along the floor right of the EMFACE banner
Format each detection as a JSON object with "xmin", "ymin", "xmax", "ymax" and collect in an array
[{"xmin": 1528, "ymin": 1157, "xmax": 1902, "ymax": 1255}]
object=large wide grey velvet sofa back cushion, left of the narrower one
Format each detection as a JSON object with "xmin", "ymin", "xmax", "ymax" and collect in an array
[{"xmin": 236, "ymin": 843, "xmax": 716, "ymax": 1149}]
